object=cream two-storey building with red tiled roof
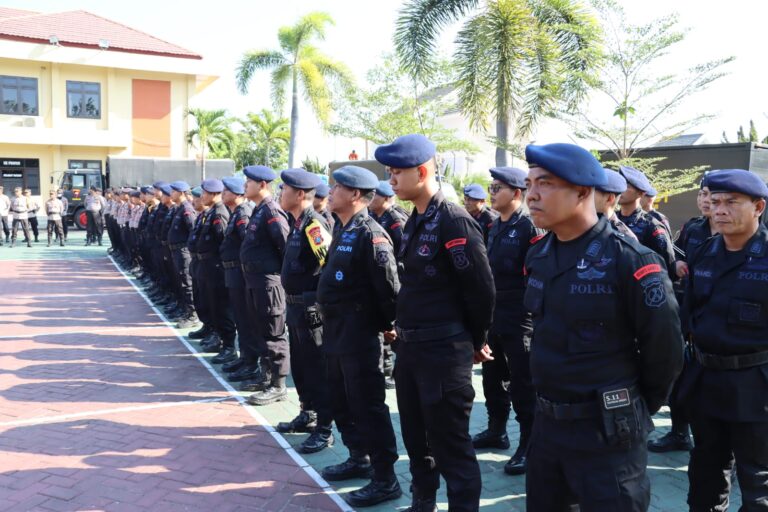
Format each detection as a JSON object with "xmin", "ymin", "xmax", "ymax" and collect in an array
[{"xmin": 0, "ymin": 7, "xmax": 218, "ymax": 200}]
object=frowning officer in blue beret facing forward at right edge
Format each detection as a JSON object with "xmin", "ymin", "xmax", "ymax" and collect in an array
[{"xmin": 679, "ymin": 169, "xmax": 768, "ymax": 512}]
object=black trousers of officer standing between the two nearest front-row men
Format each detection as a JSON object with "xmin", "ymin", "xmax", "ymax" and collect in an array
[{"xmin": 483, "ymin": 332, "xmax": 536, "ymax": 432}]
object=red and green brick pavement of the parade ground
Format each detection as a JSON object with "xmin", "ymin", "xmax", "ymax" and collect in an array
[{"xmin": 0, "ymin": 230, "xmax": 739, "ymax": 512}]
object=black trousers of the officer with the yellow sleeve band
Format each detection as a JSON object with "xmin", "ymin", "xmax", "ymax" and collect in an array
[{"xmin": 286, "ymin": 304, "xmax": 333, "ymax": 426}]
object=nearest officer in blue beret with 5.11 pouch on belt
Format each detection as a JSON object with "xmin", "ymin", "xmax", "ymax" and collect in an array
[{"xmin": 524, "ymin": 144, "xmax": 683, "ymax": 512}]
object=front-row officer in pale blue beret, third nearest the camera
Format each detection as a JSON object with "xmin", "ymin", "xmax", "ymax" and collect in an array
[{"xmin": 317, "ymin": 166, "xmax": 402, "ymax": 507}]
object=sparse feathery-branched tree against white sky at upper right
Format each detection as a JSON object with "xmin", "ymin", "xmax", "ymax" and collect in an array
[{"xmin": 568, "ymin": 0, "xmax": 733, "ymax": 159}]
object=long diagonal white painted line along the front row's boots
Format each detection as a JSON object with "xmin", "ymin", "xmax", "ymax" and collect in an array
[{"xmin": 107, "ymin": 255, "xmax": 354, "ymax": 512}]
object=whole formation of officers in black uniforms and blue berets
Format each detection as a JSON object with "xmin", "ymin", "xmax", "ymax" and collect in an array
[{"xmin": 106, "ymin": 135, "xmax": 768, "ymax": 512}]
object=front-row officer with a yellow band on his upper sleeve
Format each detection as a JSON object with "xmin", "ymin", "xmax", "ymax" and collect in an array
[{"xmin": 278, "ymin": 169, "xmax": 334, "ymax": 453}]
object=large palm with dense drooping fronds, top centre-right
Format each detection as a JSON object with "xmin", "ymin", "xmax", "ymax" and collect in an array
[{"xmin": 395, "ymin": 0, "xmax": 601, "ymax": 166}]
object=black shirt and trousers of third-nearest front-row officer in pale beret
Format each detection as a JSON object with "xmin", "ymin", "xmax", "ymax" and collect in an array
[{"xmin": 317, "ymin": 210, "xmax": 400, "ymax": 480}]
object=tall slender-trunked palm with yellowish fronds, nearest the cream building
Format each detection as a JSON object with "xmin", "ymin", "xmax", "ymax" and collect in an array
[{"xmin": 237, "ymin": 12, "xmax": 352, "ymax": 167}]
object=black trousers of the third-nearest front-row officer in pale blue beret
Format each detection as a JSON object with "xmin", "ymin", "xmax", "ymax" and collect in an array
[{"xmin": 325, "ymin": 348, "xmax": 398, "ymax": 480}]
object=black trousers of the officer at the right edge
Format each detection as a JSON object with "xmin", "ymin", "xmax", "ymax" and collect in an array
[{"xmin": 688, "ymin": 412, "xmax": 768, "ymax": 512}]
